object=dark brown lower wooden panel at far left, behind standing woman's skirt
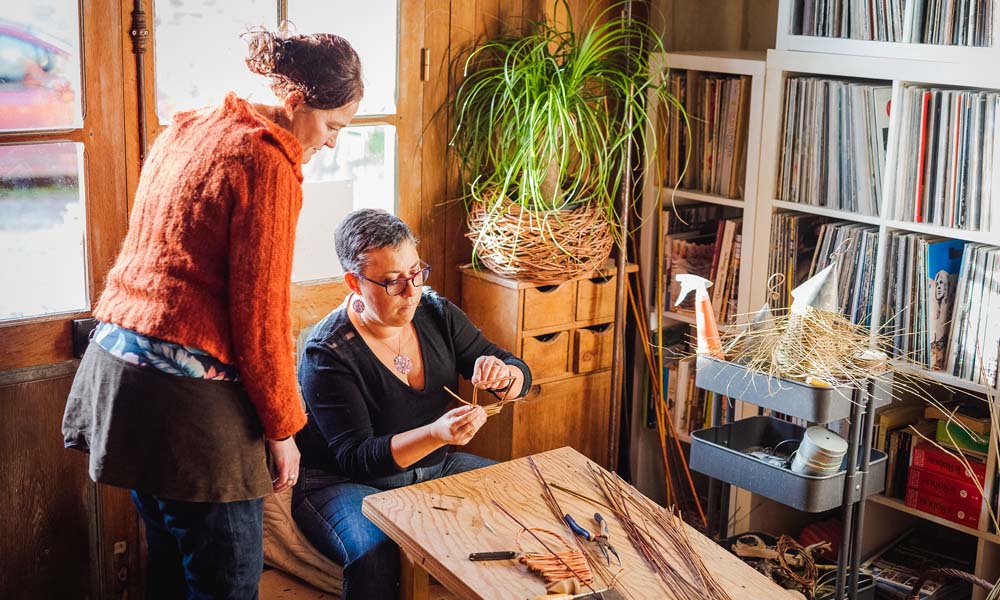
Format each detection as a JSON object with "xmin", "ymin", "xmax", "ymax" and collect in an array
[{"xmin": 0, "ymin": 375, "xmax": 100, "ymax": 599}]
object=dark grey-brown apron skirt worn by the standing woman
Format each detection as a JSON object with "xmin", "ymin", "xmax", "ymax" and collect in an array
[{"xmin": 62, "ymin": 343, "xmax": 272, "ymax": 502}]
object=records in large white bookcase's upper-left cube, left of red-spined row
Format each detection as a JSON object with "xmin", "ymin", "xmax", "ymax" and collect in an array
[{"xmin": 777, "ymin": 77, "xmax": 892, "ymax": 215}]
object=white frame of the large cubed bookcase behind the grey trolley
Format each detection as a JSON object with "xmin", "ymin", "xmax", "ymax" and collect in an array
[{"xmin": 748, "ymin": 49, "xmax": 1000, "ymax": 598}]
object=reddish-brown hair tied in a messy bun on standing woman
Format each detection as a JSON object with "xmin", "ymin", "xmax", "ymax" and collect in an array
[{"xmin": 243, "ymin": 28, "xmax": 365, "ymax": 110}]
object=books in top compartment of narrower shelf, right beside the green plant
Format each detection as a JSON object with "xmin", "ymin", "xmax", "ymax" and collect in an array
[{"xmin": 658, "ymin": 70, "xmax": 750, "ymax": 198}]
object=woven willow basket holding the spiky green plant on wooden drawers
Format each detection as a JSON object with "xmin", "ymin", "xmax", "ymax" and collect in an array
[{"xmin": 466, "ymin": 193, "xmax": 614, "ymax": 283}]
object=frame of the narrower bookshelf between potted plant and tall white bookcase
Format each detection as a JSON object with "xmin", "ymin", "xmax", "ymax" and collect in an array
[{"xmin": 631, "ymin": 51, "xmax": 766, "ymax": 510}]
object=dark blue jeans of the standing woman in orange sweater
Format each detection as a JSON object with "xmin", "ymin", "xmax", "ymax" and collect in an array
[{"xmin": 132, "ymin": 490, "xmax": 264, "ymax": 600}]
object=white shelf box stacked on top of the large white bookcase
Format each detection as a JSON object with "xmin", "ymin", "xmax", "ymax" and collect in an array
[{"xmin": 775, "ymin": 0, "xmax": 1000, "ymax": 66}]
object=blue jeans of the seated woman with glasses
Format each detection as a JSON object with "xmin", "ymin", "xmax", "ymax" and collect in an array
[{"xmin": 292, "ymin": 452, "xmax": 494, "ymax": 600}]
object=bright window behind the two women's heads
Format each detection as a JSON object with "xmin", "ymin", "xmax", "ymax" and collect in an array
[{"xmin": 153, "ymin": 0, "xmax": 399, "ymax": 281}]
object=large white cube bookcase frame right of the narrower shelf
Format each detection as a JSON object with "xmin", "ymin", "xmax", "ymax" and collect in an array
[{"xmin": 748, "ymin": 49, "xmax": 1000, "ymax": 599}]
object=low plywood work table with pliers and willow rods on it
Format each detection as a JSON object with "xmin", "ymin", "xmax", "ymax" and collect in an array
[{"xmin": 363, "ymin": 447, "xmax": 793, "ymax": 600}]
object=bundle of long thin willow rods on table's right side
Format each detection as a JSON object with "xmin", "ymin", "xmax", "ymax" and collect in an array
[{"xmin": 588, "ymin": 465, "xmax": 731, "ymax": 600}]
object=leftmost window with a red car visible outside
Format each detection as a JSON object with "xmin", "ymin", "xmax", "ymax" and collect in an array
[{"xmin": 0, "ymin": 0, "xmax": 89, "ymax": 321}]
